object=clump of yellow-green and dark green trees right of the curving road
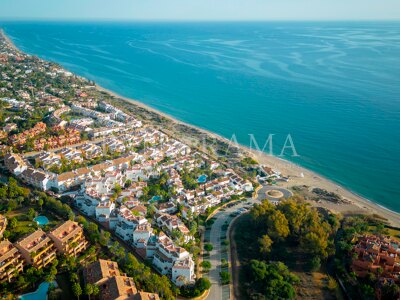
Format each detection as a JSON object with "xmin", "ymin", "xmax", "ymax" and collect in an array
[{"xmin": 236, "ymin": 197, "xmax": 339, "ymax": 299}]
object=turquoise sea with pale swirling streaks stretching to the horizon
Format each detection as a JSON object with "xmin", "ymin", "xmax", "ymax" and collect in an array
[{"xmin": 0, "ymin": 22, "xmax": 400, "ymax": 212}]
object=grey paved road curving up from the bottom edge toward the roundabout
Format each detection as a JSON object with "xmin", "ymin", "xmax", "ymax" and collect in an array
[{"xmin": 205, "ymin": 186, "xmax": 292, "ymax": 300}]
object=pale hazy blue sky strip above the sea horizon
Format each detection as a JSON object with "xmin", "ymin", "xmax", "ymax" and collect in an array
[{"xmin": 0, "ymin": 0, "xmax": 400, "ymax": 20}]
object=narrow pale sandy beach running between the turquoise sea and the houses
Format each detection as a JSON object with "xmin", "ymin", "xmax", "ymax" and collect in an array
[{"xmin": 0, "ymin": 29, "xmax": 400, "ymax": 227}]
